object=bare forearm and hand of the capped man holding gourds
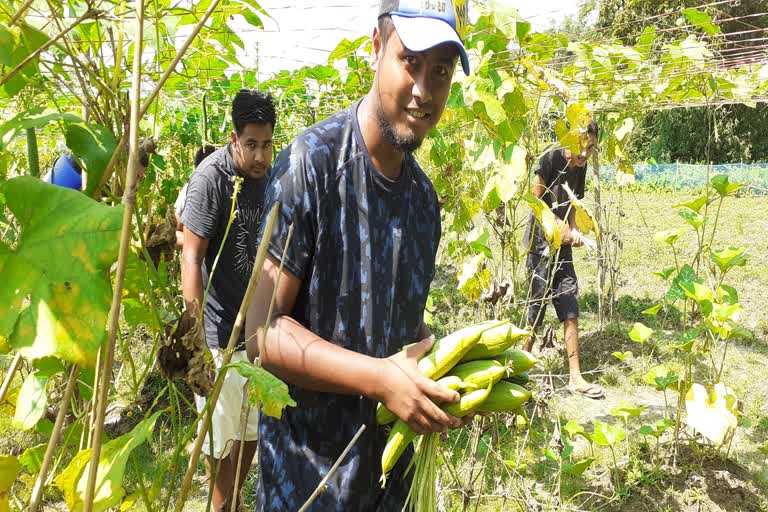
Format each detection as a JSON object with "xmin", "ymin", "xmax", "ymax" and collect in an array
[{"xmin": 246, "ymin": 256, "xmax": 461, "ymax": 433}]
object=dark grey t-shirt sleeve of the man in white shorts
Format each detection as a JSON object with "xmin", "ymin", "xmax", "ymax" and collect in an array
[{"xmin": 181, "ymin": 171, "xmax": 222, "ymax": 240}]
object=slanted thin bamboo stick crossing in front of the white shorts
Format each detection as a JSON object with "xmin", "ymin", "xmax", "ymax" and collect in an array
[{"xmin": 174, "ymin": 203, "xmax": 280, "ymax": 512}]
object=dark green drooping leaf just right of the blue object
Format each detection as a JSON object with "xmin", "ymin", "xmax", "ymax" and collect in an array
[{"xmin": 65, "ymin": 123, "xmax": 117, "ymax": 196}]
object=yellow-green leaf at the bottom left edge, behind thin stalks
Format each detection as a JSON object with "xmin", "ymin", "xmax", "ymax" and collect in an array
[{"xmin": 54, "ymin": 411, "xmax": 165, "ymax": 512}]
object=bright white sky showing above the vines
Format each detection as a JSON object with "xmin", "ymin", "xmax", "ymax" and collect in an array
[{"xmin": 228, "ymin": 0, "xmax": 582, "ymax": 79}]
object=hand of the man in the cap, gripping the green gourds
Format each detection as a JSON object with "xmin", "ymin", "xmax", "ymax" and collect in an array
[{"xmin": 372, "ymin": 336, "xmax": 463, "ymax": 434}]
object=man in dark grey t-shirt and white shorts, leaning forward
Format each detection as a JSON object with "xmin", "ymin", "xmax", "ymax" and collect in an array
[{"xmin": 181, "ymin": 89, "xmax": 276, "ymax": 511}]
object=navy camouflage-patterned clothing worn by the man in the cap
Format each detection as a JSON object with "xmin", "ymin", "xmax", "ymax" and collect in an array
[{"xmin": 257, "ymin": 102, "xmax": 440, "ymax": 512}]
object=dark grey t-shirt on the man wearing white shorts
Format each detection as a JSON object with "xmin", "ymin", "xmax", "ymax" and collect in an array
[{"xmin": 181, "ymin": 144, "xmax": 267, "ymax": 350}]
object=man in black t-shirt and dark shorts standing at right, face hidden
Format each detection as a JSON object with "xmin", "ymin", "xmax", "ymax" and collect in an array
[{"xmin": 523, "ymin": 122, "xmax": 605, "ymax": 399}]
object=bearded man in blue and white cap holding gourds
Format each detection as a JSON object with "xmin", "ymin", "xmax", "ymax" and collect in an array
[{"xmin": 246, "ymin": 0, "xmax": 469, "ymax": 512}]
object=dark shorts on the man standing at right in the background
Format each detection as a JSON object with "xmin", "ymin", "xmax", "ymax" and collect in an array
[{"xmin": 526, "ymin": 245, "xmax": 579, "ymax": 327}]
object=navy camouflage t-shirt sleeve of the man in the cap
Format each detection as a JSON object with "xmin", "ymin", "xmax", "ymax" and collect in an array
[{"xmin": 260, "ymin": 142, "xmax": 317, "ymax": 281}]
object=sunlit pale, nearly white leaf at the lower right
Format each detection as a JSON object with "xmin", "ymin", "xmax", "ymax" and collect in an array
[{"xmin": 685, "ymin": 382, "xmax": 738, "ymax": 444}]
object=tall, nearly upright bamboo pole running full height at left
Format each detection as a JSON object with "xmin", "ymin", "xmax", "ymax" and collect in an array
[{"xmin": 83, "ymin": 0, "xmax": 144, "ymax": 512}]
